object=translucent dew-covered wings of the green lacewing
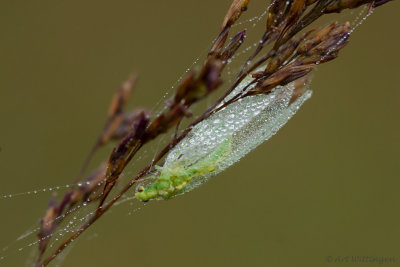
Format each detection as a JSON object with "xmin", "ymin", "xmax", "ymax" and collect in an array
[{"xmin": 164, "ymin": 79, "xmax": 312, "ymax": 194}]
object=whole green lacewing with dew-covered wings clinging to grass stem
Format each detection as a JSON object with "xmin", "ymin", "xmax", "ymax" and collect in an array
[{"xmin": 136, "ymin": 76, "xmax": 311, "ymax": 201}]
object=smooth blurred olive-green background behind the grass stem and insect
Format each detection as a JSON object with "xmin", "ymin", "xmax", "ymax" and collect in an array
[{"xmin": 0, "ymin": 0, "xmax": 400, "ymax": 267}]
